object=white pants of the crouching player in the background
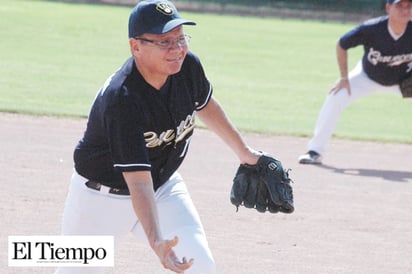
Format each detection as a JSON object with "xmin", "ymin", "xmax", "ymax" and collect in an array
[{"xmin": 308, "ymin": 62, "xmax": 402, "ymax": 154}]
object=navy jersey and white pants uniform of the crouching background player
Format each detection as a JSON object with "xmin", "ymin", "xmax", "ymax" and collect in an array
[{"xmin": 300, "ymin": 16, "xmax": 412, "ymax": 158}]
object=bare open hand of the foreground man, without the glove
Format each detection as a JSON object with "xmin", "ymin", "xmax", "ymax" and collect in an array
[{"xmin": 154, "ymin": 237, "xmax": 194, "ymax": 273}]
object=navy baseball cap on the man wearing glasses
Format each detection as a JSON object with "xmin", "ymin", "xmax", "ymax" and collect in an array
[{"xmin": 129, "ymin": 0, "xmax": 196, "ymax": 38}]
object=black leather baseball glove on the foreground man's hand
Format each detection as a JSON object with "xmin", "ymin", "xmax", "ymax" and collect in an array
[{"xmin": 230, "ymin": 154, "xmax": 295, "ymax": 213}]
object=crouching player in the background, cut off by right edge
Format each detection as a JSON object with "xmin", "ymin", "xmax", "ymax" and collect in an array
[{"xmin": 299, "ymin": 0, "xmax": 412, "ymax": 164}]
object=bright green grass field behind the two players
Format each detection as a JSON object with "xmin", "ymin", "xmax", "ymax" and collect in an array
[{"xmin": 0, "ymin": 0, "xmax": 412, "ymax": 143}]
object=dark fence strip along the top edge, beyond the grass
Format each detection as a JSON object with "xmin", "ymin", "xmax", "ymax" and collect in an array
[{"xmin": 63, "ymin": 0, "xmax": 386, "ymax": 21}]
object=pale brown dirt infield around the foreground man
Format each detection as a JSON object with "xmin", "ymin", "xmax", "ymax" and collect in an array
[{"xmin": 0, "ymin": 114, "xmax": 412, "ymax": 274}]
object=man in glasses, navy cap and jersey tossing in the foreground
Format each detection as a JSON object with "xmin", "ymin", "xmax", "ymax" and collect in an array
[{"xmin": 57, "ymin": 0, "xmax": 261, "ymax": 274}]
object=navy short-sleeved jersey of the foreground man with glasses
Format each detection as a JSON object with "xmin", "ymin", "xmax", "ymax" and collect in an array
[{"xmin": 74, "ymin": 52, "xmax": 212, "ymax": 192}]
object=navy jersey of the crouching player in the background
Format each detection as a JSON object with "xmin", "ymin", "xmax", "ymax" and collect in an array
[{"xmin": 339, "ymin": 16, "xmax": 412, "ymax": 86}]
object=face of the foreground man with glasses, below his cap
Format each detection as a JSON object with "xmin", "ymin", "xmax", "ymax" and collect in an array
[{"xmin": 135, "ymin": 26, "xmax": 188, "ymax": 76}]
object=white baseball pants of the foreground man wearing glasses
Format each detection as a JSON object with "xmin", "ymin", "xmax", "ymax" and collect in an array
[{"xmin": 56, "ymin": 172, "xmax": 216, "ymax": 274}]
